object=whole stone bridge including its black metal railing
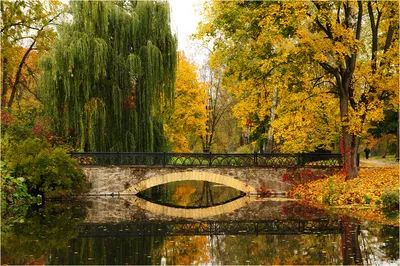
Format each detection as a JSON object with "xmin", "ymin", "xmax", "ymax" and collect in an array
[{"xmin": 71, "ymin": 152, "xmax": 341, "ymax": 195}]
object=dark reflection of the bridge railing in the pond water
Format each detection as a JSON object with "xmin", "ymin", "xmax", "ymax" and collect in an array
[{"xmin": 77, "ymin": 219, "xmax": 341, "ymax": 237}]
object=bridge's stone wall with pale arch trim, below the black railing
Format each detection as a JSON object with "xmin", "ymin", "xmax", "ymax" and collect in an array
[{"xmin": 81, "ymin": 166, "xmax": 335, "ymax": 195}]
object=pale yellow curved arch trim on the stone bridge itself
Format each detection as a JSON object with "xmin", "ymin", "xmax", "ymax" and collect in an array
[{"xmin": 121, "ymin": 171, "xmax": 256, "ymax": 194}]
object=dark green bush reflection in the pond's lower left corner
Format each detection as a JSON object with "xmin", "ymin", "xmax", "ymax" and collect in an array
[{"xmin": 1, "ymin": 202, "xmax": 86, "ymax": 264}]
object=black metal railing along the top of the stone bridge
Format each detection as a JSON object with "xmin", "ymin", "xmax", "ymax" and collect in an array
[{"xmin": 70, "ymin": 152, "xmax": 342, "ymax": 168}]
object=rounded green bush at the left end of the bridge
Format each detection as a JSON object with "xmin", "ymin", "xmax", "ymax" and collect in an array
[{"xmin": 3, "ymin": 138, "xmax": 88, "ymax": 197}]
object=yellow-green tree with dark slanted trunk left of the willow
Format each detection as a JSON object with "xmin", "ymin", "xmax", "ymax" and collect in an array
[{"xmin": 0, "ymin": 0, "xmax": 64, "ymax": 108}]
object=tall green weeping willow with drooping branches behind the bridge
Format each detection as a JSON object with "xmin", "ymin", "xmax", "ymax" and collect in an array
[{"xmin": 41, "ymin": 1, "xmax": 177, "ymax": 151}]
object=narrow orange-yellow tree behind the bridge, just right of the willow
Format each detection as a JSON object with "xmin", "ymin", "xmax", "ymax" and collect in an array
[{"xmin": 165, "ymin": 52, "xmax": 208, "ymax": 152}]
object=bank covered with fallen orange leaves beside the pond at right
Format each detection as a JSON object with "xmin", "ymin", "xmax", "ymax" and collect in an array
[{"xmin": 288, "ymin": 167, "xmax": 399, "ymax": 225}]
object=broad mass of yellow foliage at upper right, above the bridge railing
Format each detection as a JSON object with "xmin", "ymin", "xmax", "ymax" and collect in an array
[{"xmin": 197, "ymin": 0, "xmax": 399, "ymax": 152}]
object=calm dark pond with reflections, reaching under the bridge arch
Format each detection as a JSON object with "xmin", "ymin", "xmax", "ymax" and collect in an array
[{"xmin": 1, "ymin": 182, "xmax": 400, "ymax": 265}]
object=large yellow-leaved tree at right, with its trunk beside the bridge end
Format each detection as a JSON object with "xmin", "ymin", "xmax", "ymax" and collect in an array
[{"xmin": 199, "ymin": 1, "xmax": 399, "ymax": 178}]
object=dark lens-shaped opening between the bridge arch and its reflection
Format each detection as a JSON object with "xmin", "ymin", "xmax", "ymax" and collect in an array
[{"xmin": 137, "ymin": 180, "xmax": 246, "ymax": 208}]
